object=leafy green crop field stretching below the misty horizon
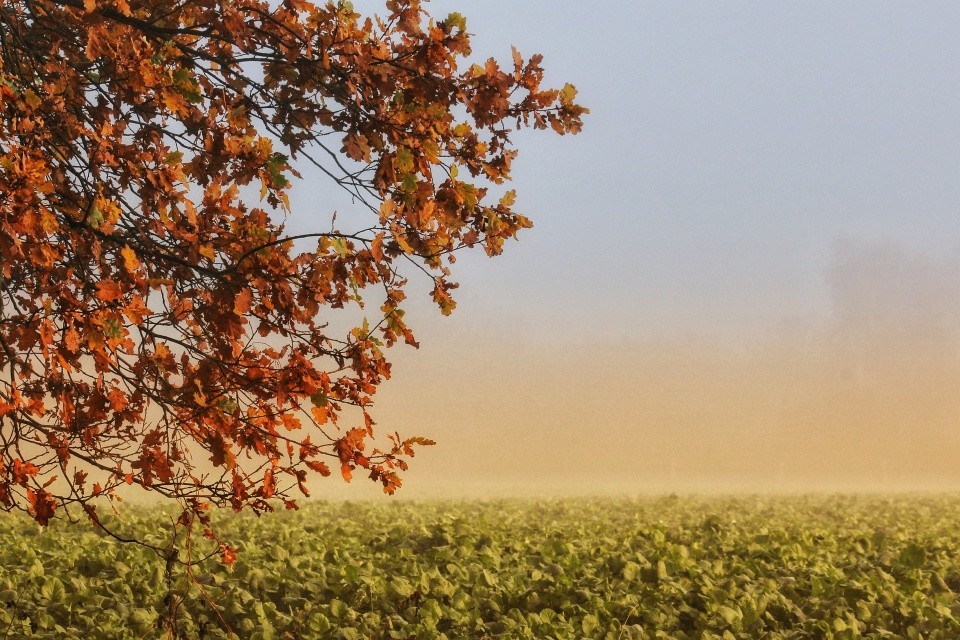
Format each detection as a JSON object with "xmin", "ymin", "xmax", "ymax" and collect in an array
[{"xmin": 0, "ymin": 496, "xmax": 960, "ymax": 640}]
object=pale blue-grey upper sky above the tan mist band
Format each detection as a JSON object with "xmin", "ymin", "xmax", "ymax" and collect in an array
[{"xmin": 372, "ymin": 1, "xmax": 960, "ymax": 342}]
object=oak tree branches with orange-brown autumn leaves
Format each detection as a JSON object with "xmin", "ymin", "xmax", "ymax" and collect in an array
[{"xmin": 0, "ymin": 0, "xmax": 586, "ymax": 540}]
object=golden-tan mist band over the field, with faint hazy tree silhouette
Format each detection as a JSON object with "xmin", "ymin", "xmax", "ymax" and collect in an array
[{"xmin": 358, "ymin": 239, "xmax": 960, "ymax": 497}]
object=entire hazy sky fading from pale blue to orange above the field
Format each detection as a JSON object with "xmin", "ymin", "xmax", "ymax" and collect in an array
[{"xmin": 293, "ymin": 0, "xmax": 960, "ymax": 497}]
